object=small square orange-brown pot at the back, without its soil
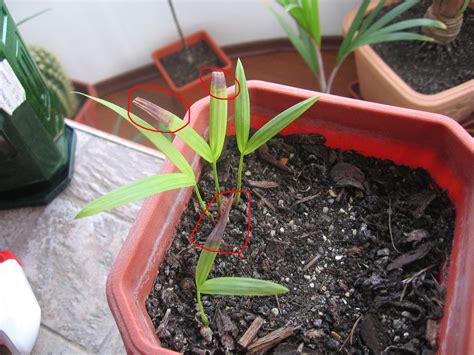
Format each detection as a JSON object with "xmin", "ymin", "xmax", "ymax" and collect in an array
[{"xmin": 152, "ymin": 31, "xmax": 232, "ymax": 103}]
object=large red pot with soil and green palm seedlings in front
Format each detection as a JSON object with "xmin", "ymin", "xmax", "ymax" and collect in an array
[{"xmin": 78, "ymin": 58, "xmax": 474, "ymax": 354}]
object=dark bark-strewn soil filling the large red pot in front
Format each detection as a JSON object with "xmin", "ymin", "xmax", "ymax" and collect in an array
[{"xmin": 146, "ymin": 135, "xmax": 455, "ymax": 354}]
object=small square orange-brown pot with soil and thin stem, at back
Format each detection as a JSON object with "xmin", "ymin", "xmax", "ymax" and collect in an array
[{"xmin": 152, "ymin": 0, "xmax": 232, "ymax": 103}]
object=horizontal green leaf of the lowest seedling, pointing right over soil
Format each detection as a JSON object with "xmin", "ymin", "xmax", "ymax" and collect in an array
[{"xmin": 199, "ymin": 277, "xmax": 288, "ymax": 296}]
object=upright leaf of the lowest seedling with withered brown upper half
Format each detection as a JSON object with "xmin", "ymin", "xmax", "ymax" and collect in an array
[{"xmin": 195, "ymin": 196, "xmax": 233, "ymax": 290}]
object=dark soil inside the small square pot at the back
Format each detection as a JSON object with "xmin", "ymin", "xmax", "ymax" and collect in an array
[{"xmin": 160, "ymin": 41, "xmax": 224, "ymax": 87}]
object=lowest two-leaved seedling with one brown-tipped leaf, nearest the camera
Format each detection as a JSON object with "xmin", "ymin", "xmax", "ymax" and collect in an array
[{"xmin": 195, "ymin": 195, "xmax": 288, "ymax": 326}]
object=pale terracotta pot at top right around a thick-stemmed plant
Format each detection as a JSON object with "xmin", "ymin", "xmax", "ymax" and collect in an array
[{"xmin": 343, "ymin": 0, "xmax": 474, "ymax": 121}]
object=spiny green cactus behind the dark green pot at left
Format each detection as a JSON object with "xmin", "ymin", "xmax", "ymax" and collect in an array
[{"xmin": 28, "ymin": 46, "xmax": 78, "ymax": 118}]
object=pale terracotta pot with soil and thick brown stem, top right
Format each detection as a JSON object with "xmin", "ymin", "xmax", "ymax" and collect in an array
[{"xmin": 343, "ymin": 0, "xmax": 474, "ymax": 123}]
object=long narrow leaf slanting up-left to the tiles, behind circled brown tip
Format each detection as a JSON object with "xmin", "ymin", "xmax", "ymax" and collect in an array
[{"xmin": 76, "ymin": 92, "xmax": 194, "ymax": 178}]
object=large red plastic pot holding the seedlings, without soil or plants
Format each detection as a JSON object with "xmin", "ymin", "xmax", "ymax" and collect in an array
[{"xmin": 107, "ymin": 81, "xmax": 474, "ymax": 354}]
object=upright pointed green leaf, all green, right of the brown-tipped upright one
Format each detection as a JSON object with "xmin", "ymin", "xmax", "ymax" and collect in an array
[{"xmin": 234, "ymin": 59, "xmax": 250, "ymax": 153}]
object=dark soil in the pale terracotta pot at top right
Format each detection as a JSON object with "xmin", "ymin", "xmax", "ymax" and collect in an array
[{"xmin": 373, "ymin": 0, "xmax": 474, "ymax": 94}]
